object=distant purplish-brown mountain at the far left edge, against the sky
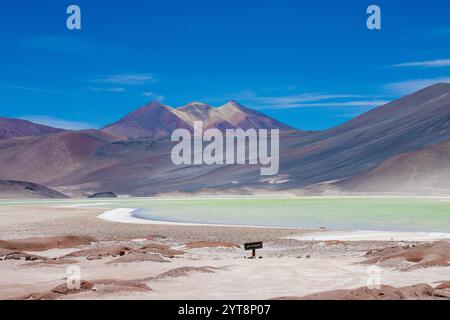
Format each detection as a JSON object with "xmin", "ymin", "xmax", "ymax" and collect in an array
[{"xmin": 0, "ymin": 118, "xmax": 62, "ymax": 140}]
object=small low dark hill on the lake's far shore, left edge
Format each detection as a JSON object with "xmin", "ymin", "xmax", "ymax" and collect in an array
[{"xmin": 0, "ymin": 181, "xmax": 68, "ymax": 199}]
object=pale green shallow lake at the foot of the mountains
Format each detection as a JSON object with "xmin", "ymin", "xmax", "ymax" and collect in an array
[{"xmin": 0, "ymin": 198, "xmax": 450, "ymax": 233}]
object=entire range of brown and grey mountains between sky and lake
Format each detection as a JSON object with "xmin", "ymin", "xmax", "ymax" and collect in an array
[{"xmin": 0, "ymin": 83, "xmax": 450, "ymax": 196}]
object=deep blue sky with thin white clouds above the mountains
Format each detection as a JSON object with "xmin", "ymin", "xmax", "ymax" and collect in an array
[{"xmin": 0, "ymin": 0, "xmax": 450, "ymax": 130}]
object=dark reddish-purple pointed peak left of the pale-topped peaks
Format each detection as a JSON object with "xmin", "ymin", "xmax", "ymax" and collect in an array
[{"xmin": 102, "ymin": 101, "xmax": 192, "ymax": 139}]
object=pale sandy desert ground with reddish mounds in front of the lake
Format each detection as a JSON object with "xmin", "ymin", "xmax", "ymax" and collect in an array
[{"xmin": 0, "ymin": 201, "xmax": 450, "ymax": 300}]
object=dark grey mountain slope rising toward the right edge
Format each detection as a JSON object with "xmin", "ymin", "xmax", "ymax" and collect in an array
[{"xmin": 151, "ymin": 83, "xmax": 450, "ymax": 194}]
